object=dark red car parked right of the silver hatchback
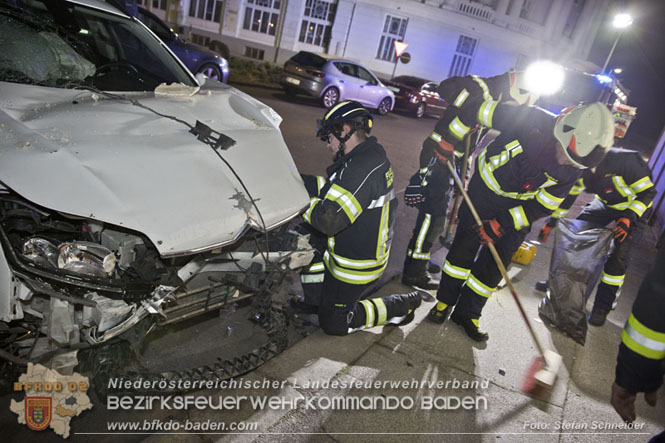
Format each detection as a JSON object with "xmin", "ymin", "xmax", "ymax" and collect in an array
[{"xmin": 385, "ymin": 75, "xmax": 448, "ymax": 118}]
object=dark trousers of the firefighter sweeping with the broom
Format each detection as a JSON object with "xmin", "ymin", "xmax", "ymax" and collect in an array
[{"xmin": 436, "ymin": 174, "xmax": 529, "ymax": 319}]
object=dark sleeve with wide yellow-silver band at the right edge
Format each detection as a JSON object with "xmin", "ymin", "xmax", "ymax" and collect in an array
[{"xmin": 616, "ymin": 248, "xmax": 665, "ymax": 392}]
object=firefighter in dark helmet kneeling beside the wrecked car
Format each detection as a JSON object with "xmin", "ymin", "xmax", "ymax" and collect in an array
[{"xmin": 301, "ymin": 101, "xmax": 421, "ymax": 335}]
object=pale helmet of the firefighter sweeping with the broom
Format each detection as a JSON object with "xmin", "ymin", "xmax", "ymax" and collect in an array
[{"xmin": 554, "ymin": 102, "xmax": 614, "ymax": 168}]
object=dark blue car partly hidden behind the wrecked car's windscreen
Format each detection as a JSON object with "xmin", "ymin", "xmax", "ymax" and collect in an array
[{"xmin": 137, "ymin": 8, "xmax": 229, "ymax": 83}]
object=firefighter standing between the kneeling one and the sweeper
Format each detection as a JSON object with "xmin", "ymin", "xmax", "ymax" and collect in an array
[{"xmin": 402, "ymin": 71, "xmax": 538, "ymax": 290}]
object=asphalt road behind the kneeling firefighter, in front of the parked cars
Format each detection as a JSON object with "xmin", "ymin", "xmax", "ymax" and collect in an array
[{"xmin": 233, "ymin": 81, "xmax": 438, "ymax": 277}]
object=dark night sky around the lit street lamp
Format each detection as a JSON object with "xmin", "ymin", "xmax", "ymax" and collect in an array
[{"xmin": 590, "ymin": 0, "xmax": 665, "ymax": 154}]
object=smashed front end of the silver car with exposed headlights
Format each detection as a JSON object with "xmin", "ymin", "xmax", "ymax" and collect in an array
[{"xmin": 0, "ymin": 192, "xmax": 313, "ymax": 386}]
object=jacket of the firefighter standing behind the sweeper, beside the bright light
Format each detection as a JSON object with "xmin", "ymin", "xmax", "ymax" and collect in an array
[{"xmin": 420, "ymin": 72, "xmax": 510, "ymax": 169}]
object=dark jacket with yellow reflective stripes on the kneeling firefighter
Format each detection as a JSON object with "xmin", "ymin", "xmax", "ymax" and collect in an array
[{"xmin": 303, "ymin": 137, "xmax": 397, "ymax": 285}]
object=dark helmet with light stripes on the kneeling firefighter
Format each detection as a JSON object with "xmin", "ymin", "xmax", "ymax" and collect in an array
[{"xmin": 316, "ymin": 100, "xmax": 372, "ymax": 143}]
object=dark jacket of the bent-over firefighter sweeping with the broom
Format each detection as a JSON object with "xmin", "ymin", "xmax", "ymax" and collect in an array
[{"xmin": 443, "ymin": 98, "xmax": 581, "ymax": 231}]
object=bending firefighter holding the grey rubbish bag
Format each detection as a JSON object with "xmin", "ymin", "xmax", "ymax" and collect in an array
[{"xmin": 538, "ymin": 148, "xmax": 656, "ymax": 326}]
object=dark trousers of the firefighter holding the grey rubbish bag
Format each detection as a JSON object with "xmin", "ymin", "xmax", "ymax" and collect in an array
[{"xmin": 577, "ymin": 198, "xmax": 644, "ymax": 311}]
